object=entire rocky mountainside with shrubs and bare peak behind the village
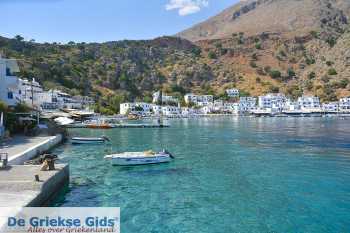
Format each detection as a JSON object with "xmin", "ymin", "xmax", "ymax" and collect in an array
[{"xmin": 0, "ymin": 0, "xmax": 350, "ymax": 112}]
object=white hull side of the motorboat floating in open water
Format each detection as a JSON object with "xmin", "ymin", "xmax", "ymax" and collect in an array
[{"xmin": 111, "ymin": 156, "xmax": 171, "ymax": 166}]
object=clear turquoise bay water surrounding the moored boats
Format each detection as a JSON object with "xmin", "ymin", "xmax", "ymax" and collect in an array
[{"xmin": 51, "ymin": 118, "xmax": 350, "ymax": 233}]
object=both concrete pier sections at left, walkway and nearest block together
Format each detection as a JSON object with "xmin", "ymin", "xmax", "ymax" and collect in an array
[{"xmin": 0, "ymin": 134, "xmax": 69, "ymax": 207}]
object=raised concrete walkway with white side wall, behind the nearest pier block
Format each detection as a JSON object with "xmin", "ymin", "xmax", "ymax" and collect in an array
[{"xmin": 0, "ymin": 134, "xmax": 62, "ymax": 165}]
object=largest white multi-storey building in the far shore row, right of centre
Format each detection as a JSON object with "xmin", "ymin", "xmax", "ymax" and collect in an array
[{"xmin": 258, "ymin": 93, "xmax": 287, "ymax": 112}]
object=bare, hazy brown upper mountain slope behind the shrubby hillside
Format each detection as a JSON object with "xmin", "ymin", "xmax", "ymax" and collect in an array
[{"xmin": 177, "ymin": 0, "xmax": 350, "ymax": 41}]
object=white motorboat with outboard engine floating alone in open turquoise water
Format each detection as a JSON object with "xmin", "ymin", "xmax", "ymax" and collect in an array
[{"xmin": 105, "ymin": 150, "xmax": 174, "ymax": 166}]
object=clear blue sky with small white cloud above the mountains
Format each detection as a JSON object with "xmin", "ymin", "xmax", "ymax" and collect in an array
[{"xmin": 0, "ymin": 0, "xmax": 238, "ymax": 43}]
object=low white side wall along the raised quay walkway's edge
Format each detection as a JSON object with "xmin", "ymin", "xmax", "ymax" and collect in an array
[{"xmin": 9, "ymin": 134, "xmax": 63, "ymax": 165}]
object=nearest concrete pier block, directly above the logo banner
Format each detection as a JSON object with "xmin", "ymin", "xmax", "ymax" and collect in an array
[{"xmin": 0, "ymin": 164, "xmax": 69, "ymax": 207}]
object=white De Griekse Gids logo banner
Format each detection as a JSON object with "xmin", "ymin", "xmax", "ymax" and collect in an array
[{"xmin": 0, "ymin": 207, "xmax": 120, "ymax": 233}]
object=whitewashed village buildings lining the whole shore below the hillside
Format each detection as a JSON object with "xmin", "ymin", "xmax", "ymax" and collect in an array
[{"xmin": 0, "ymin": 54, "xmax": 350, "ymax": 136}]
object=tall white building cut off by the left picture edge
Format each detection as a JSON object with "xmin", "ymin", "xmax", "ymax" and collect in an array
[{"xmin": 0, "ymin": 56, "xmax": 20, "ymax": 106}]
